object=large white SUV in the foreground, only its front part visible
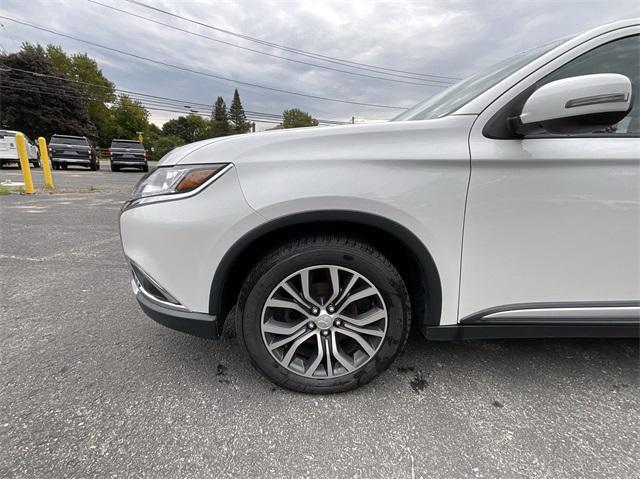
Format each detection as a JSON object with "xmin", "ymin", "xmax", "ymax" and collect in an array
[{"xmin": 120, "ymin": 20, "xmax": 640, "ymax": 392}]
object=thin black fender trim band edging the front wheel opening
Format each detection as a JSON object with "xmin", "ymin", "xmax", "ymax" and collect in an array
[{"xmin": 209, "ymin": 210, "xmax": 442, "ymax": 325}]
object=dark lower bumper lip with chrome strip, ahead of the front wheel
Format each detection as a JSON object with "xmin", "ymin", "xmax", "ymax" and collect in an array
[{"xmin": 131, "ymin": 279, "xmax": 220, "ymax": 339}]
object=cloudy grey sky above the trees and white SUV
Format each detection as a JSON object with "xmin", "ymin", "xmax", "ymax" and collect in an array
[{"xmin": 0, "ymin": 0, "xmax": 640, "ymax": 126}]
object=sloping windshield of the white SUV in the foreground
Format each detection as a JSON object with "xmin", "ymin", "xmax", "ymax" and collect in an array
[{"xmin": 391, "ymin": 38, "xmax": 567, "ymax": 121}]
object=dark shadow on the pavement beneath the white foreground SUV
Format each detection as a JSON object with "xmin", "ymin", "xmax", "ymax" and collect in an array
[{"xmin": 146, "ymin": 317, "xmax": 640, "ymax": 398}]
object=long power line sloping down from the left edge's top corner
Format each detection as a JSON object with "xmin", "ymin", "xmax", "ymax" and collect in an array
[{"xmin": 0, "ymin": 15, "xmax": 406, "ymax": 110}]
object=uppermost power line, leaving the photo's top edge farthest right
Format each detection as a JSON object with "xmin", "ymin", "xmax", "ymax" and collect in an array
[{"xmin": 125, "ymin": 0, "xmax": 460, "ymax": 80}]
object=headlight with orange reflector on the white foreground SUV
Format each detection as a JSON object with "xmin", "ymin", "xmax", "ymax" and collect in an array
[{"xmin": 123, "ymin": 163, "xmax": 231, "ymax": 210}]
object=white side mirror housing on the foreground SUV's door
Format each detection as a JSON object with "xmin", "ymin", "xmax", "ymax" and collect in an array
[{"xmin": 509, "ymin": 73, "xmax": 632, "ymax": 135}]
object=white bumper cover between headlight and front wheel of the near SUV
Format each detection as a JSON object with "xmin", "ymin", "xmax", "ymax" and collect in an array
[{"xmin": 120, "ymin": 168, "xmax": 264, "ymax": 323}]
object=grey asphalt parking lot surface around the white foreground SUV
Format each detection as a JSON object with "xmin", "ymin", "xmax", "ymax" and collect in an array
[{"xmin": 0, "ymin": 164, "xmax": 640, "ymax": 478}]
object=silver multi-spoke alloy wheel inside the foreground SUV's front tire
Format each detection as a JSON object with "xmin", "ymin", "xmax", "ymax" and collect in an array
[{"xmin": 260, "ymin": 265, "xmax": 388, "ymax": 379}]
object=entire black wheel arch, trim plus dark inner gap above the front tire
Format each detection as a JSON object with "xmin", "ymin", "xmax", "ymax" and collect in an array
[{"xmin": 209, "ymin": 210, "xmax": 442, "ymax": 331}]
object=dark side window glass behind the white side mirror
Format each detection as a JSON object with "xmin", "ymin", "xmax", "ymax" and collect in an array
[{"xmin": 536, "ymin": 35, "xmax": 640, "ymax": 136}]
